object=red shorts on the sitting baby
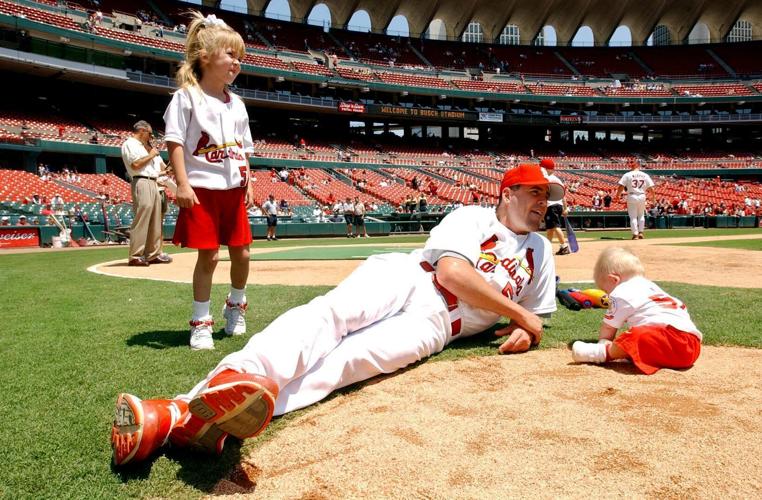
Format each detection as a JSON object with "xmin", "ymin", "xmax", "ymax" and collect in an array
[{"xmin": 614, "ymin": 325, "xmax": 701, "ymax": 375}]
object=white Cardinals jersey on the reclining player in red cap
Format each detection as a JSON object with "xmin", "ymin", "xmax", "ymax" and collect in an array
[{"xmin": 414, "ymin": 206, "xmax": 556, "ymax": 336}]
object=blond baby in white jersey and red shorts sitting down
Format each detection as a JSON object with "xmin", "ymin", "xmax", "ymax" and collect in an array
[{"xmin": 572, "ymin": 247, "xmax": 701, "ymax": 375}]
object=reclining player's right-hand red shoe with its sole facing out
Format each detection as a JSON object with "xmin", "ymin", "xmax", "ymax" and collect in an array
[{"xmin": 170, "ymin": 370, "xmax": 278, "ymax": 453}]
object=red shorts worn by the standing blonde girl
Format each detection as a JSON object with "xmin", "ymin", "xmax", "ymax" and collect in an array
[{"xmin": 172, "ymin": 188, "xmax": 251, "ymax": 250}]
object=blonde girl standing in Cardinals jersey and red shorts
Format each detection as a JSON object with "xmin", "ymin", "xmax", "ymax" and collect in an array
[{"xmin": 164, "ymin": 12, "xmax": 254, "ymax": 350}]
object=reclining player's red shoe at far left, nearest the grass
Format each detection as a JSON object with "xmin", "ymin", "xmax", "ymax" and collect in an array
[{"xmin": 111, "ymin": 393, "xmax": 188, "ymax": 465}]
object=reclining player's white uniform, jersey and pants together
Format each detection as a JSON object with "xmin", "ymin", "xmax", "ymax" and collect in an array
[{"xmin": 178, "ymin": 206, "xmax": 556, "ymax": 415}]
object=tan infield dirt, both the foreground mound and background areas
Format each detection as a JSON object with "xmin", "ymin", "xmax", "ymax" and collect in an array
[{"xmin": 90, "ymin": 235, "xmax": 762, "ymax": 499}]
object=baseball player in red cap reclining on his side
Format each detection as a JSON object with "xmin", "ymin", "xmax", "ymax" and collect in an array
[{"xmin": 111, "ymin": 164, "xmax": 564, "ymax": 465}]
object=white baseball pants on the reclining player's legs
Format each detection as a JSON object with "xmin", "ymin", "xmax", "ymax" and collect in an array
[{"xmin": 178, "ymin": 253, "xmax": 451, "ymax": 415}]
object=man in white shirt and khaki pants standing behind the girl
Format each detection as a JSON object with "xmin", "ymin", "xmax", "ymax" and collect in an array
[{"xmin": 122, "ymin": 120, "xmax": 172, "ymax": 266}]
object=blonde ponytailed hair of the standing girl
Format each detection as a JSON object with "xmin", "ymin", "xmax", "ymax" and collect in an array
[{"xmin": 175, "ymin": 10, "xmax": 246, "ymax": 88}]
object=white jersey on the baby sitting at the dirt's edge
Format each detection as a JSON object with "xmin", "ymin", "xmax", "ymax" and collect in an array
[{"xmin": 603, "ymin": 276, "xmax": 701, "ymax": 340}]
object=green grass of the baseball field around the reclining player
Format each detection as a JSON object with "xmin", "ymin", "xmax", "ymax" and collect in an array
[{"xmin": 0, "ymin": 231, "xmax": 762, "ymax": 498}]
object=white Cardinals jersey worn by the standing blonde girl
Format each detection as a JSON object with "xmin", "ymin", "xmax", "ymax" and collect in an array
[{"xmin": 164, "ymin": 87, "xmax": 254, "ymax": 190}]
